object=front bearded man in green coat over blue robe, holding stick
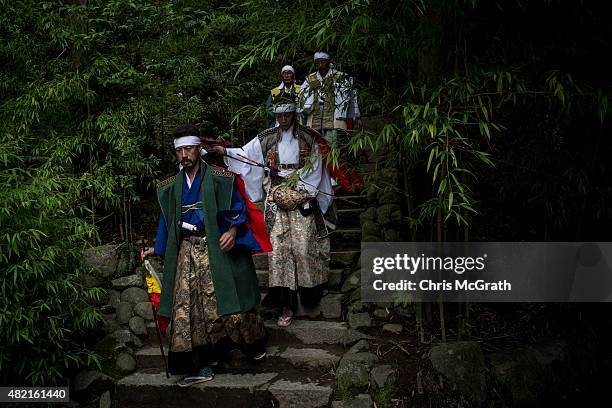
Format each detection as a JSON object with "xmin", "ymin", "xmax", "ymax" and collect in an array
[{"xmin": 140, "ymin": 125, "xmax": 271, "ymax": 387}]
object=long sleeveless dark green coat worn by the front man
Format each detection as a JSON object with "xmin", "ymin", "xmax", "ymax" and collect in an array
[{"xmin": 157, "ymin": 161, "xmax": 261, "ymax": 317}]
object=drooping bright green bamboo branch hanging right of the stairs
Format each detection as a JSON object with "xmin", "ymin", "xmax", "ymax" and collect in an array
[{"xmin": 396, "ymin": 69, "xmax": 584, "ymax": 230}]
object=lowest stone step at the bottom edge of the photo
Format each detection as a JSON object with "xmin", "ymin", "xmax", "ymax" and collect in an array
[{"xmin": 115, "ymin": 372, "xmax": 333, "ymax": 408}]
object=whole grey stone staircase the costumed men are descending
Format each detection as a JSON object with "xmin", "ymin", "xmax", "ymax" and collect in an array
[{"xmin": 115, "ymin": 190, "xmax": 367, "ymax": 408}]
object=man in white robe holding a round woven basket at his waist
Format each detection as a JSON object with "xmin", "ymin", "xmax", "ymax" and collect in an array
[{"xmin": 211, "ymin": 102, "xmax": 333, "ymax": 327}]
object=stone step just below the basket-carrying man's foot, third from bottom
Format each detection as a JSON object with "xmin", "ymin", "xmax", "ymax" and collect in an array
[{"xmin": 265, "ymin": 319, "xmax": 369, "ymax": 347}]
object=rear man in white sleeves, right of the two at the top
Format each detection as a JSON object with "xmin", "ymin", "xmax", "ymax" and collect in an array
[{"xmin": 300, "ymin": 51, "xmax": 360, "ymax": 144}]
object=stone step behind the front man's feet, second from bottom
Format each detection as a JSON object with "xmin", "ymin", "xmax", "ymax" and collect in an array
[{"xmin": 134, "ymin": 345, "xmax": 344, "ymax": 374}]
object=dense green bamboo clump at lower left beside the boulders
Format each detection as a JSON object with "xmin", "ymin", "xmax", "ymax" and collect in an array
[{"xmin": 0, "ymin": 148, "xmax": 101, "ymax": 385}]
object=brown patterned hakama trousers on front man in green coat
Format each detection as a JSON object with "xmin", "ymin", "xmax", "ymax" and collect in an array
[{"xmin": 168, "ymin": 237, "xmax": 266, "ymax": 374}]
